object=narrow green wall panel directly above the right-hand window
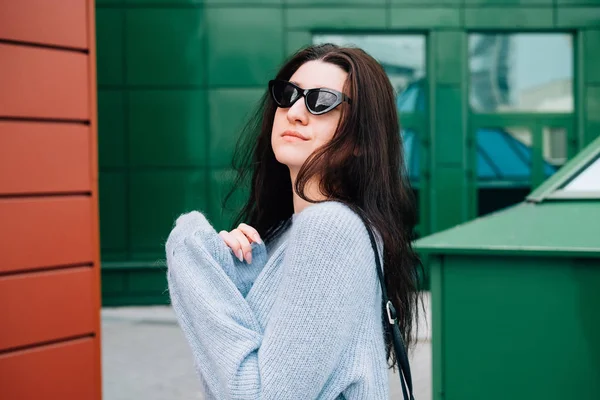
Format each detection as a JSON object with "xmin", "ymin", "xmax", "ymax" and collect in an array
[{"xmin": 465, "ymin": 7, "xmax": 554, "ymax": 29}]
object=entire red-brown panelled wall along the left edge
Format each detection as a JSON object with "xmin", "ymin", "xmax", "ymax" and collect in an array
[{"xmin": 0, "ymin": 0, "xmax": 102, "ymax": 400}]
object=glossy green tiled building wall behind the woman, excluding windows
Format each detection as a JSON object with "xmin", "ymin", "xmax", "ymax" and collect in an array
[{"xmin": 96, "ymin": 0, "xmax": 600, "ymax": 304}]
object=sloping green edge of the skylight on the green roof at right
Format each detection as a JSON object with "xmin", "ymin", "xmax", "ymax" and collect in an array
[{"xmin": 525, "ymin": 136, "xmax": 600, "ymax": 203}]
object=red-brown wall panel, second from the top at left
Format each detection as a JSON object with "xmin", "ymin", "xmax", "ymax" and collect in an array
[{"xmin": 0, "ymin": 43, "xmax": 90, "ymax": 121}]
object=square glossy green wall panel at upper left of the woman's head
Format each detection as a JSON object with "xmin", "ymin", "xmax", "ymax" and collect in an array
[{"xmin": 206, "ymin": 8, "xmax": 284, "ymax": 86}]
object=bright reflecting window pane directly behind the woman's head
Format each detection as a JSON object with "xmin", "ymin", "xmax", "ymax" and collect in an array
[{"xmin": 313, "ymin": 35, "xmax": 425, "ymax": 112}]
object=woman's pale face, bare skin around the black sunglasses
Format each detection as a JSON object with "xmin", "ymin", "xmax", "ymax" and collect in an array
[{"xmin": 271, "ymin": 61, "xmax": 348, "ymax": 172}]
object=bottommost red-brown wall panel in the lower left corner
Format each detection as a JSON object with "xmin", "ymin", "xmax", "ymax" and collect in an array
[{"xmin": 0, "ymin": 339, "xmax": 100, "ymax": 400}]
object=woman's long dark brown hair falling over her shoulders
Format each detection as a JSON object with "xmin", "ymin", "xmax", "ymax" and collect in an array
[{"xmin": 227, "ymin": 44, "xmax": 422, "ymax": 364}]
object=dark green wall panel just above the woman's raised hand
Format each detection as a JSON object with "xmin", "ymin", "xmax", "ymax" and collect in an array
[{"xmin": 209, "ymin": 169, "xmax": 248, "ymax": 231}]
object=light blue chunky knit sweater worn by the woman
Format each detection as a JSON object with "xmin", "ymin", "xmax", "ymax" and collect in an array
[{"xmin": 166, "ymin": 202, "xmax": 388, "ymax": 400}]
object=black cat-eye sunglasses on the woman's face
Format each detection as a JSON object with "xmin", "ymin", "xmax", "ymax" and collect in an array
[{"xmin": 269, "ymin": 80, "xmax": 352, "ymax": 115}]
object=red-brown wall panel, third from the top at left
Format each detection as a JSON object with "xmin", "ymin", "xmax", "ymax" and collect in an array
[{"xmin": 0, "ymin": 120, "xmax": 92, "ymax": 196}]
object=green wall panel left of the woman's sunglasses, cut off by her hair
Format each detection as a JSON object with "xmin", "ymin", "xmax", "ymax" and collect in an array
[{"xmin": 209, "ymin": 89, "xmax": 265, "ymax": 167}]
